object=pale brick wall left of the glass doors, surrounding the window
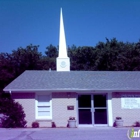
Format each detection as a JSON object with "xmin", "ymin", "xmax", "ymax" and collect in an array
[{"xmin": 12, "ymin": 92, "xmax": 77, "ymax": 127}]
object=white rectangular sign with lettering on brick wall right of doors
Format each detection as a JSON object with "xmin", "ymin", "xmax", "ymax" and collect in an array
[{"xmin": 121, "ymin": 94, "xmax": 140, "ymax": 109}]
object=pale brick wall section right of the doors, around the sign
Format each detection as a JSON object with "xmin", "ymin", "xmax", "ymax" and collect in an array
[{"xmin": 112, "ymin": 93, "xmax": 140, "ymax": 126}]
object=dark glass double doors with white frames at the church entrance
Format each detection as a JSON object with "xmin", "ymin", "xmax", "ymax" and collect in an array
[{"xmin": 78, "ymin": 94, "xmax": 107, "ymax": 125}]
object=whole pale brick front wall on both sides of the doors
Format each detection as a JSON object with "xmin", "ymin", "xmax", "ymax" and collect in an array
[{"xmin": 12, "ymin": 92, "xmax": 140, "ymax": 127}]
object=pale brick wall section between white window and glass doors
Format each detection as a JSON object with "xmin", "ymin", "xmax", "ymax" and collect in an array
[{"xmin": 52, "ymin": 92, "xmax": 77, "ymax": 127}]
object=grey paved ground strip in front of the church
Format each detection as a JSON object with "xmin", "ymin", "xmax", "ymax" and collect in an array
[{"xmin": 0, "ymin": 127, "xmax": 140, "ymax": 140}]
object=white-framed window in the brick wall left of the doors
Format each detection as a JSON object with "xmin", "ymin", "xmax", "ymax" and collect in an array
[{"xmin": 36, "ymin": 93, "xmax": 52, "ymax": 119}]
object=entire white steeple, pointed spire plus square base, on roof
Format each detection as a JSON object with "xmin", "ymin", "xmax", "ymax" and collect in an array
[{"xmin": 56, "ymin": 8, "xmax": 70, "ymax": 71}]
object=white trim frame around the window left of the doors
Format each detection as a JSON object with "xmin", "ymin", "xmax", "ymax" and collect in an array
[{"xmin": 35, "ymin": 92, "xmax": 52, "ymax": 120}]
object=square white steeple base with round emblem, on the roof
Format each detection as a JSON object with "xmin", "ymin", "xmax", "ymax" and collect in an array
[{"xmin": 56, "ymin": 57, "xmax": 70, "ymax": 71}]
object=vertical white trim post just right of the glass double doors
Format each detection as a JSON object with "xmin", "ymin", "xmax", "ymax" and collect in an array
[{"xmin": 107, "ymin": 92, "xmax": 113, "ymax": 126}]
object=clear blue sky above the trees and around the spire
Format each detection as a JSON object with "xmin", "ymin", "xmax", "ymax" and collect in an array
[{"xmin": 0, "ymin": 0, "xmax": 140, "ymax": 53}]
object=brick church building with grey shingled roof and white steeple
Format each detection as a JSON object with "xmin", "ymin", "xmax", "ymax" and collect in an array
[{"xmin": 3, "ymin": 9, "xmax": 140, "ymax": 127}]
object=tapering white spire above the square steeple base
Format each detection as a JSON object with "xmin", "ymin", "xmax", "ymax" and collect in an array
[{"xmin": 58, "ymin": 8, "xmax": 68, "ymax": 58}]
